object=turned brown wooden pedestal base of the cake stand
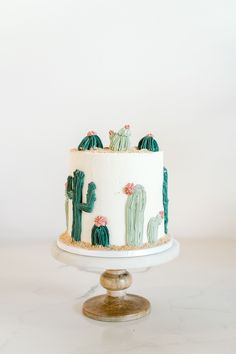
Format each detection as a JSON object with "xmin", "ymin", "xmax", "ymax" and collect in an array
[{"xmin": 83, "ymin": 269, "xmax": 151, "ymax": 322}]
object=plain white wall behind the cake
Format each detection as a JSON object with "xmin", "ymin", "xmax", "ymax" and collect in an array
[{"xmin": 0, "ymin": 0, "xmax": 236, "ymax": 238}]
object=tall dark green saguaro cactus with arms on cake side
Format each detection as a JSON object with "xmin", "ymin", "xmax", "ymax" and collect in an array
[{"xmin": 66, "ymin": 170, "xmax": 96, "ymax": 241}]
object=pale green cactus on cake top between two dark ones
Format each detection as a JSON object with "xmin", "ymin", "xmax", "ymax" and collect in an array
[{"xmin": 109, "ymin": 125, "xmax": 130, "ymax": 151}]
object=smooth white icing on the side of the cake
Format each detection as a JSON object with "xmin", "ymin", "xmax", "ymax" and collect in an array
[{"xmin": 69, "ymin": 150, "xmax": 164, "ymax": 245}]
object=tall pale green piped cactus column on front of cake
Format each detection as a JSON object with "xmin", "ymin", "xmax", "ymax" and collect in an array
[{"xmin": 125, "ymin": 184, "xmax": 146, "ymax": 246}]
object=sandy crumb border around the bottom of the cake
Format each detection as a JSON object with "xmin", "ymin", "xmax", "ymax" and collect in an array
[{"xmin": 59, "ymin": 232, "xmax": 171, "ymax": 251}]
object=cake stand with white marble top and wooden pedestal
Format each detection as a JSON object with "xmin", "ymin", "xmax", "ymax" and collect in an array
[{"xmin": 52, "ymin": 240, "xmax": 179, "ymax": 322}]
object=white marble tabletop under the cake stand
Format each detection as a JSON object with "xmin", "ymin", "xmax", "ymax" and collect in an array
[{"xmin": 0, "ymin": 239, "xmax": 236, "ymax": 354}]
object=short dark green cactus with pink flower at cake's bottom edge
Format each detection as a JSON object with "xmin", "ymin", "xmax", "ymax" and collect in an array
[{"xmin": 91, "ymin": 216, "xmax": 109, "ymax": 247}]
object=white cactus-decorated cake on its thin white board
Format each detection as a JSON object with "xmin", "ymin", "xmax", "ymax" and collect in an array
[{"xmin": 57, "ymin": 125, "xmax": 172, "ymax": 257}]
